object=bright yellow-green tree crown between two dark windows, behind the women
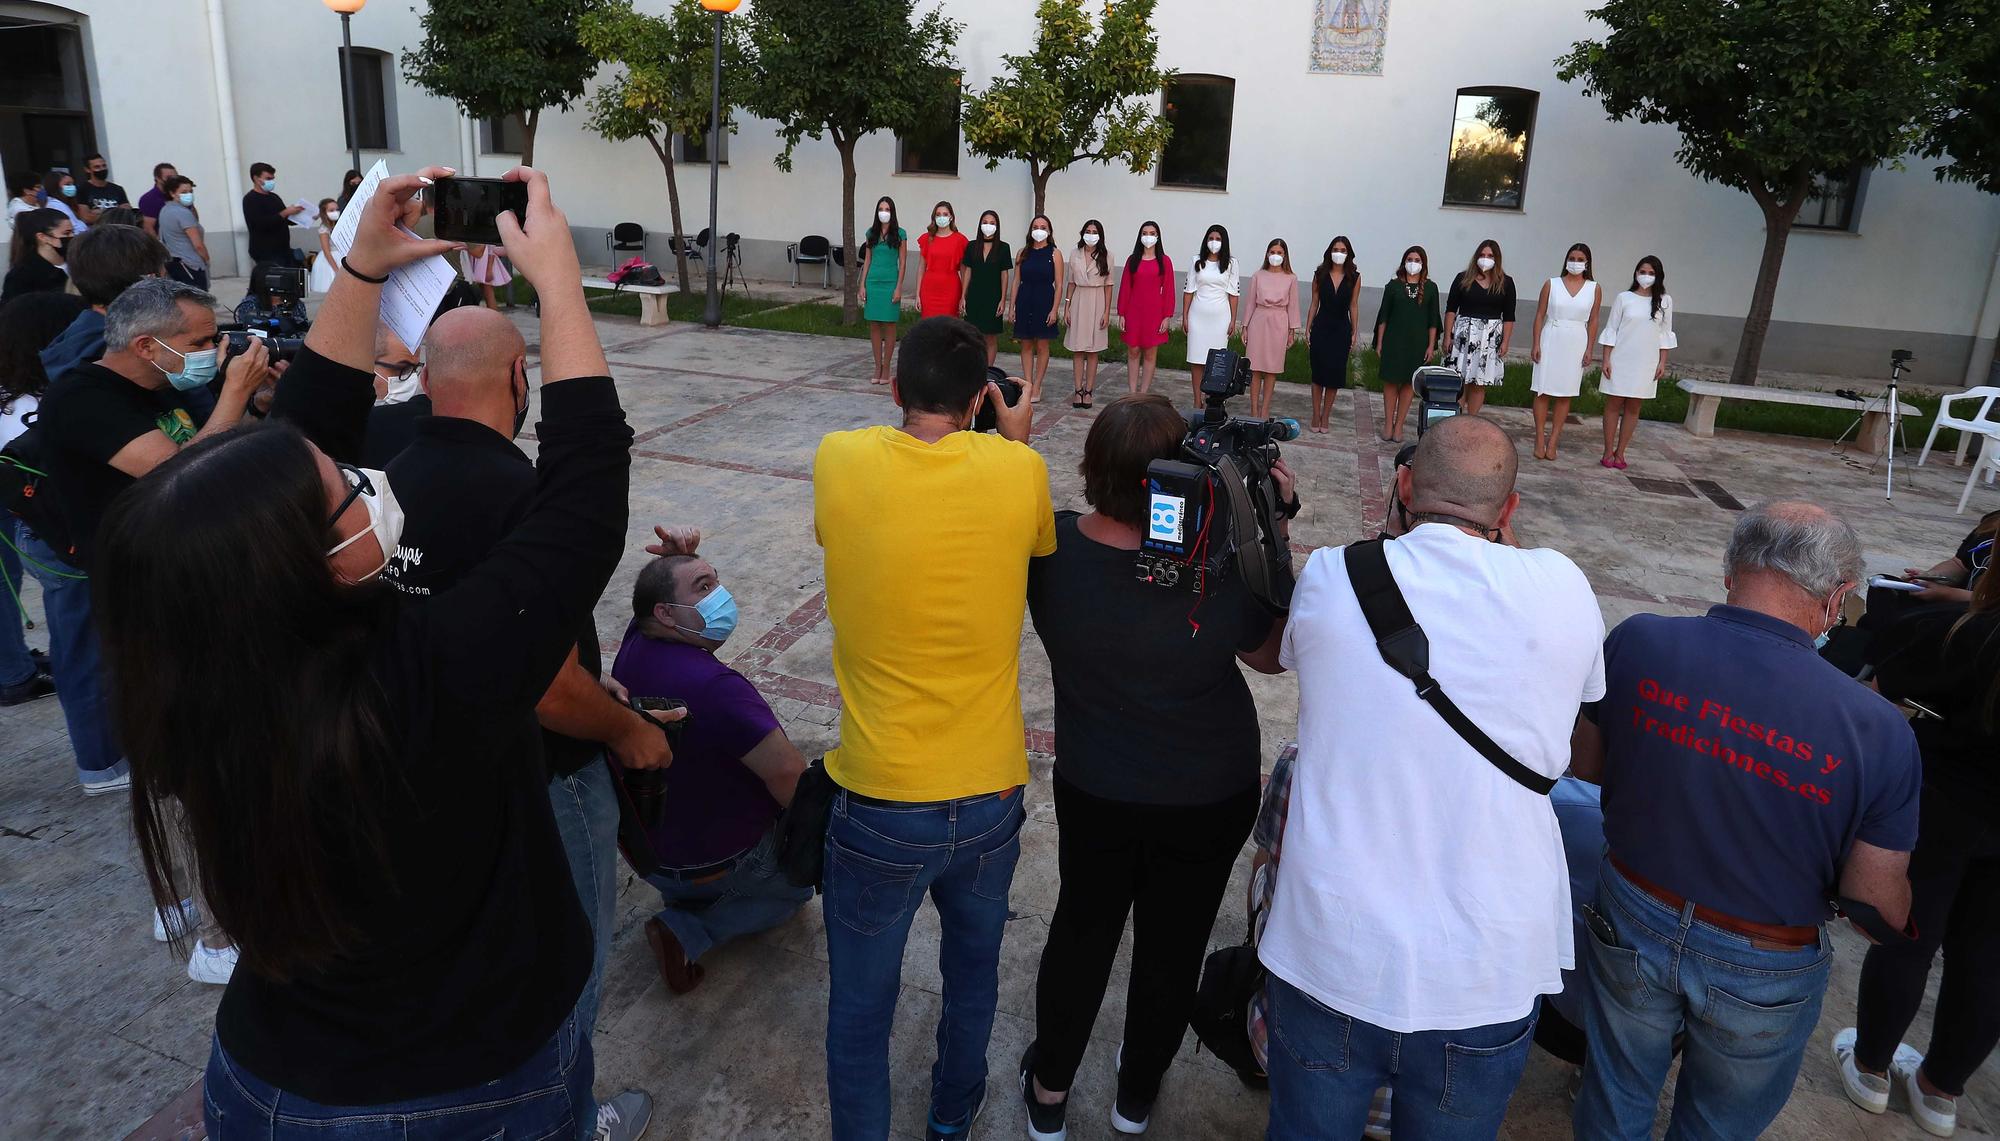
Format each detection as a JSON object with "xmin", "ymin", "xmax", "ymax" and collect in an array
[{"xmin": 964, "ymin": 0, "xmax": 1174, "ymax": 212}]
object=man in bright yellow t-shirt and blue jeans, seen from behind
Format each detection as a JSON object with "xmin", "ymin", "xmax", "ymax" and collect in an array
[{"xmin": 812, "ymin": 316, "xmax": 1056, "ymax": 1141}]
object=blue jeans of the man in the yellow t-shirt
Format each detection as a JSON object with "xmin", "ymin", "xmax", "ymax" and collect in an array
[{"xmin": 824, "ymin": 789, "xmax": 1024, "ymax": 1141}]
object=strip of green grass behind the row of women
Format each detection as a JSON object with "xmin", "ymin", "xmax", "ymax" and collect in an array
[{"xmin": 724, "ymin": 302, "xmax": 1958, "ymax": 448}]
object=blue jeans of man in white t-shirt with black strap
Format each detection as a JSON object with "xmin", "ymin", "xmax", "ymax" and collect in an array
[{"xmin": 1264, "ymin": 975, "xmax": 1534, "ymax": 1141}]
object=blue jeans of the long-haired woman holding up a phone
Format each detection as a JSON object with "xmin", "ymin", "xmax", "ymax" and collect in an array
[{"xmin": 202, "ymin": 1017, "xmax": 596, "ymax": 1141}]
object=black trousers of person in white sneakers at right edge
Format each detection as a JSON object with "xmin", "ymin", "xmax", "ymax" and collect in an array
[{"xmin": 1854, "ymin": 787, "xmax": 2000, "ymax": 1097}]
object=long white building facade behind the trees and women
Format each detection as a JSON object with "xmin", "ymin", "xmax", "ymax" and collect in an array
[{"xmin": 0, "ymin": 0, "xmax": 2000, "ymax": 384}]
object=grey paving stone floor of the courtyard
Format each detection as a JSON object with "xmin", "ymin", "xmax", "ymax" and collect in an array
[{"xmin": 0, "ymin": 310, "xmax": 2000, "ymax": 1141}]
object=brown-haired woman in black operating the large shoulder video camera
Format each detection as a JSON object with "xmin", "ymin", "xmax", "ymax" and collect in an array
[{"xmin": 1022, "ymin": 394, "xmax": 1292, "ymax": 1137}]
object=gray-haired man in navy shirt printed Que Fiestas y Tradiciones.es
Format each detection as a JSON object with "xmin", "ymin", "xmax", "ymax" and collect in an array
[{"xmin": 1574, "ymin": 500, "xmax": 1920, "ymax": 1139}]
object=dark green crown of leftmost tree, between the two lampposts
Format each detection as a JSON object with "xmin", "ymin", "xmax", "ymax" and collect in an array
[{"xmin": 402, "ymin": 0, "xmax": 604, "ymax": 162}]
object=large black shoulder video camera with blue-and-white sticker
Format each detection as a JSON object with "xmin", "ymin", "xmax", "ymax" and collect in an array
[{"xmin": 1138, "ymin": 348, "xmax": 1298, "ymax": 615}]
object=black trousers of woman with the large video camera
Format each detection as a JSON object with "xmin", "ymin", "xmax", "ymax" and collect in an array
[{"xmin": 1034, "ymin": 773, "xmax": 1260, "ymax": 1095}]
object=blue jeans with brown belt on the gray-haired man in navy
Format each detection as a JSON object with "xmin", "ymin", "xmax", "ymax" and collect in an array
[{"xmin": 1568, "ymin": 861, "xmax": 1832, "ymax": 1139}]
